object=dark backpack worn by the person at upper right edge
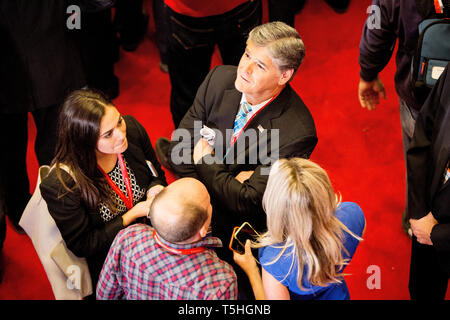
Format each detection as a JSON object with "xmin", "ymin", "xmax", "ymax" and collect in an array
[{"xmin": 411, "ymin": 0, "xmax": 450, "ymax": 89}]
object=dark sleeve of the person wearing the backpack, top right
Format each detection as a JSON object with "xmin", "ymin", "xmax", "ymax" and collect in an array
[{"xmin": 359, "ymin": 0, "xmax": 399, "ymax": 81}]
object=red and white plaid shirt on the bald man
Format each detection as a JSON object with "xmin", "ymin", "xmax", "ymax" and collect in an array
[{"xmin": 97, "ymin": 224, "xmax": 237, "ymax": 300}]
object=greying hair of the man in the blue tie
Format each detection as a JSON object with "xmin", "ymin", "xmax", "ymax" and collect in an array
[{"xmin": 248, "ymin": 21, "xmax": 305, "ymax": 74}]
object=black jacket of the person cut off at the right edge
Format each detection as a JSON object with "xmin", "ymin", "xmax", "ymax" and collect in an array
[{"xmin": 407, "ymin": 65, "xmax": 450, "ymax": 272}]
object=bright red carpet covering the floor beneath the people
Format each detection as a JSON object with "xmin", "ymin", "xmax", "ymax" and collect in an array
[{"xmin": 0, "ymin": 0, "xmax": 450, "ymax": 300}]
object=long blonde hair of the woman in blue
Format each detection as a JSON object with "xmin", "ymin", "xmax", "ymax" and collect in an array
[{"xmin": 258, "ymin": 158, "xmax": 361, "ymax": 289}]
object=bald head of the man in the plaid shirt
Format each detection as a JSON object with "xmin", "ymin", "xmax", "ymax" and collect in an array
[{"xmin": 150, "ymin": 178, "xmax": 211, "ymax": 243}]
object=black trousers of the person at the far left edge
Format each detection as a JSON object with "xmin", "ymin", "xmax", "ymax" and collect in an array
[{"xmin": 0, "ymin": 105, "xmax": 60, "ymax": 228}]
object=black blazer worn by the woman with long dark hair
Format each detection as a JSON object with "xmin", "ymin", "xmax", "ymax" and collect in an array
[{"xmin": 40, "ymin": 116, "xmax": 167, "ymax": 284}]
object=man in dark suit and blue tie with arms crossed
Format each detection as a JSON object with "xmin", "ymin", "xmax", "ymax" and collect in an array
[{"xmin": 156, "ymin": 22, "xmax": 317, "ymax": 298}]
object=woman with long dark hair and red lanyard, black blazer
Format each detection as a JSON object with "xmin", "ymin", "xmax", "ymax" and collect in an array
[{"xmin": 40, "ymin": 90, "xmax": 167, "ymax": 290}]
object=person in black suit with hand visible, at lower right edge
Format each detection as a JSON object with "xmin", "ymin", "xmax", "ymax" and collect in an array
[{"xmin": 407, "ymin": 64, "xmax": 450, "ymax": 300}]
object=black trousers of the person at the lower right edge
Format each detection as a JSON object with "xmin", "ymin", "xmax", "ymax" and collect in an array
[{"xmin": 409, "ymin": 237, "xmax": 450, "ymax": 300}]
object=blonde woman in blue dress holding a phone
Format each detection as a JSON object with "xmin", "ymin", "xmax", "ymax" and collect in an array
[{"xmin": 234, "ymin": 158, "xmax": 365, "ymax": 300}]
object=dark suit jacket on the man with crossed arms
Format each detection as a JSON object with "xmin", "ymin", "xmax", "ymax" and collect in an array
[{"xmin": 169, "ymin": 66, "xmax": 317, "ymax": 248}]
